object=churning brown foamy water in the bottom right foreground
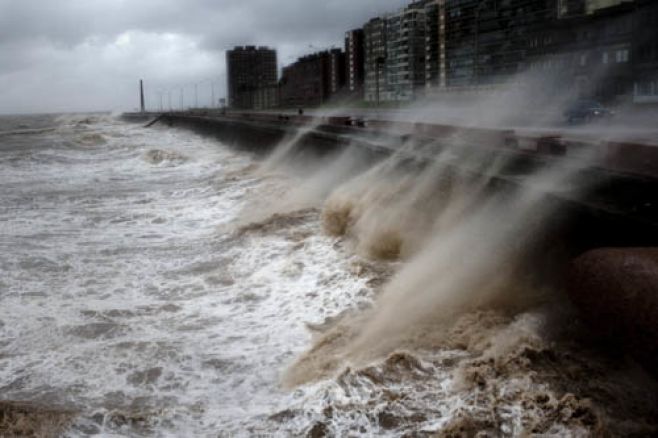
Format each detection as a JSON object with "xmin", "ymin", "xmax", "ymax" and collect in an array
[{"xmin": 278, "ymin": 309, "xmax": 658, "ymax": 437}]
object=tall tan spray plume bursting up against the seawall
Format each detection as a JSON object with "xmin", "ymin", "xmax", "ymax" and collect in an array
[{"xmin": 308, "ymin": 137, "xmax": 578, "ymax": 362}]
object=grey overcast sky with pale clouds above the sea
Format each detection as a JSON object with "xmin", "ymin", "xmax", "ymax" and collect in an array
[{"xmin": 0, "ymin": 0, "xmax": 408, "ymax": 114}]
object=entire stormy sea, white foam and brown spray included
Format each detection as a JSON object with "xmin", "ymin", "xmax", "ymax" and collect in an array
[{"xmin": 0, "ymin": 114, "xmax": 658, "ymax": 437}]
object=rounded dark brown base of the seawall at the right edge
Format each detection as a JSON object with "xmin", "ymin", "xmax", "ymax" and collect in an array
[{"xmin": 569, "ymin": 248, "xmax": 658, "ymax": 376}]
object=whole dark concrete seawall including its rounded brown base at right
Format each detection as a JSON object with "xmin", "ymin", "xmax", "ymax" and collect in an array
[{"xmin": 125, "ymin": 113, "xmax": 658, "ymax": 376}]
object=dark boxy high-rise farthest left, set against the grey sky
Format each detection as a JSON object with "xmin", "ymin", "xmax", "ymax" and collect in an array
[{"xmin": 226, "ymin": 46, "xmax": 278, "ymax": 109}]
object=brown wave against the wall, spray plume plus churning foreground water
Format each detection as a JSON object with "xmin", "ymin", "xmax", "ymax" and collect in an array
[{"xmin": 283, "ymin": 135, "xmax": 658, "ymax": 436}]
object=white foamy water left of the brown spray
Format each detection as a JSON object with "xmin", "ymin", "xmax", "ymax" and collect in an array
[{"xmin": 0, "ymin": 115, "xmax": 369, "ymax": 436}]
